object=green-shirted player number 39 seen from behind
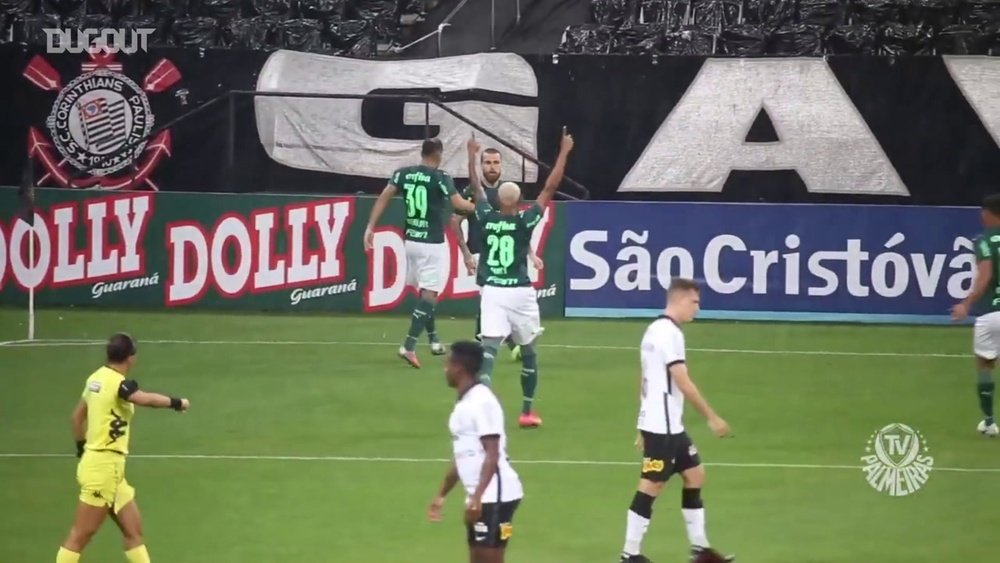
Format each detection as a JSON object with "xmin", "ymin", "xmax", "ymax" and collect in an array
[{"xmin": 365, "ymin": 139, "xmax": 475, "ymax": 368}]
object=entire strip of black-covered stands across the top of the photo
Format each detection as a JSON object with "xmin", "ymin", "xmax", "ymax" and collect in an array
[{"xmin": 0, "ymin": 0, "xmax": 1000, "ymax": 57}]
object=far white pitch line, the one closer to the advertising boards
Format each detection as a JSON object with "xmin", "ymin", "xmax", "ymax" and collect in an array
[{"xmin": 0, "ymin": 339, "xmax": 969, "ymax": 359}]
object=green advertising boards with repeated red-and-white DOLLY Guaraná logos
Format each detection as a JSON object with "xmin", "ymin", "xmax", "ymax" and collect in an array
[{"xmin": 0, "ymin": 188, "xmax": 565, "ymax": 316}]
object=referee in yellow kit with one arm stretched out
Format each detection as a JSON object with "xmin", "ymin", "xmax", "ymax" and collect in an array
[{"xmin": 56, "ymin": 333, "xmax": 190, "ymax": 563}]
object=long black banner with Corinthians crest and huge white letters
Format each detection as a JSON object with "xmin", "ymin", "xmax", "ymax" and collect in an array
[{"xmin": 0, "ymin": 45, "xmax": 1000, "ymax": 205}]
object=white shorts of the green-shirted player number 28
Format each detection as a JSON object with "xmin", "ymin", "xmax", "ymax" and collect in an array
[{"xmin": 479, "ymin": 285, "xmax": 542, "ymax": 345}]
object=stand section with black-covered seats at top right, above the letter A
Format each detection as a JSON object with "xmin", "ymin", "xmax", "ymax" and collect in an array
[{"xmin": 558, "ymin": 0, "xmax": 1000, "ymax": 56}]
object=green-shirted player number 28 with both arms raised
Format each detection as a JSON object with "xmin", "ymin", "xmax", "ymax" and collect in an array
[{"xmin": 469, "ymin": 128, "xmax": 573, "ymax": 428}]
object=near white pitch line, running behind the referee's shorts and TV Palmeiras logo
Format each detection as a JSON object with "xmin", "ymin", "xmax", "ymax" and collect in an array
[{"xmin": 0, "ymin": 453, "xmax": 1000, "ymax": 473}]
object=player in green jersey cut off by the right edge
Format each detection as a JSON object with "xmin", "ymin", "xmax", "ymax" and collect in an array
[{"xmin": 951, "ymin": 194, "xmax": 1000, "ymax": 437}]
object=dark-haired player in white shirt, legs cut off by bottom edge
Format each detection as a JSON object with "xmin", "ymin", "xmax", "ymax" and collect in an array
[{"xmin": 427, "ymin": 342, "xmax": 524, "ymax": 563}]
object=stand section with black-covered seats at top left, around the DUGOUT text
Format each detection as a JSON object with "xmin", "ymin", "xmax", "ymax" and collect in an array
[{"xmin": 0, "ymin": 0, "xmax": 434, "ymax": 57}]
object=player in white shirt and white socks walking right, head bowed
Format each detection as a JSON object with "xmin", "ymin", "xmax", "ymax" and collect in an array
[{"xmin": 620, "ymin": 278, "xmax": 735, "ymax": 563}]
